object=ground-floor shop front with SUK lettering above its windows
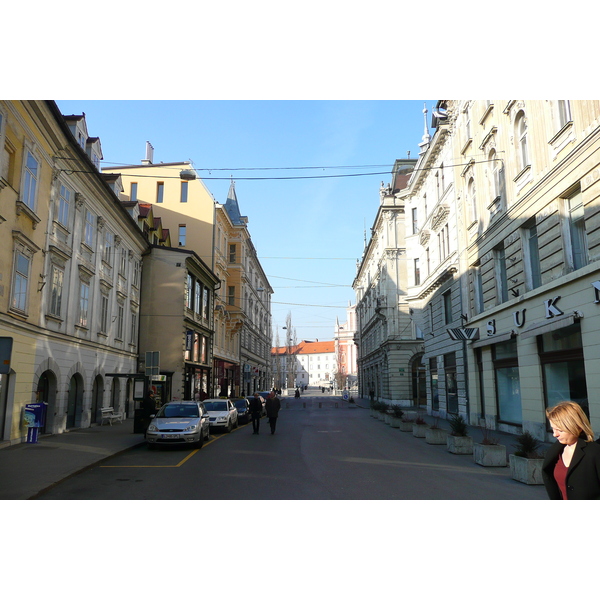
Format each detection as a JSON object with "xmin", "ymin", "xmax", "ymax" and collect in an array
[{"xmin": 468, "ymin": 265, "xmax": 600, "ymax": 441}]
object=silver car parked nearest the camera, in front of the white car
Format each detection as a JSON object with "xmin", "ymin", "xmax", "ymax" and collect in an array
[{"xmin": 146, "ymin": 402, "xmax": 209, "ymax": 448}]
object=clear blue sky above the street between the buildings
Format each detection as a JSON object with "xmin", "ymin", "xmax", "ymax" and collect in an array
[{"xmin": 57, "ymin": 100, "xmax": 434, "ymax": 343}]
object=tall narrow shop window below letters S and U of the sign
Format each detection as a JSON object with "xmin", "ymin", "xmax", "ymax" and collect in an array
[{"xmin": 493, "ymin": 339, "xmax": 523, "ymax": 425}]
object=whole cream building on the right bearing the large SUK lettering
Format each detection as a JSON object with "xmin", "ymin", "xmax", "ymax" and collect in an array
[{"xmin": 445, "ymin": 100, "xmax": 600, "ymax": 440}]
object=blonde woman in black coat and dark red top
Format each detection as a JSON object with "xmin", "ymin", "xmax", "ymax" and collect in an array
[{"xmin": 542, "ymin": 402, "xmax": 600, "ymax": 500}]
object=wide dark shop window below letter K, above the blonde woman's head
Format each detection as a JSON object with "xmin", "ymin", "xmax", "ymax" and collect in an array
[{"xmin": 538, "ymin": 323, "xmax": 589, "ymax": 414}]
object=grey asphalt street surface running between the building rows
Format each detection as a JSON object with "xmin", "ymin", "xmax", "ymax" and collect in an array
[{"xmin": 39, "ymin": 394, "xmax": 547, "ymax": 500}]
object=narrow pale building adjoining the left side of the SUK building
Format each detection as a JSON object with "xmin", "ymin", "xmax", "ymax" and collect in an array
[{"xmin": 405, "ymin": 108, "xmax": 468, "ymax": 418}]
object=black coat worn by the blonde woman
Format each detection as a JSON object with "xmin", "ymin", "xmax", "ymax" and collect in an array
[{"xmin": 542, "ymin": 438, "xmax": 600, "ymax": 500}]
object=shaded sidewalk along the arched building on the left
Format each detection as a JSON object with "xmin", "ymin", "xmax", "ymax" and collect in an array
[{"xmin": 0, "ymin": 419, "xmax": 145, "ymax": 500}]
